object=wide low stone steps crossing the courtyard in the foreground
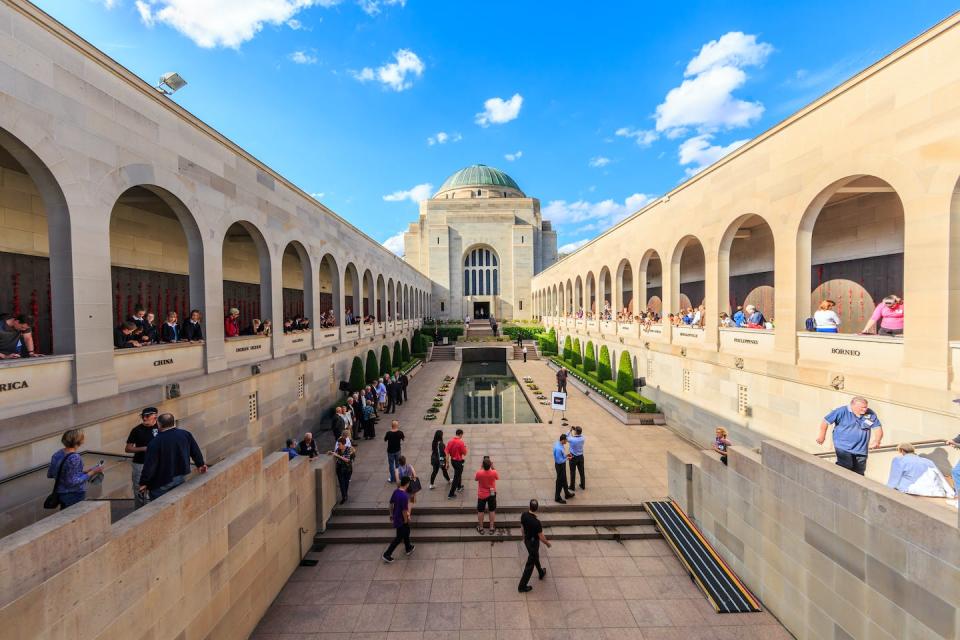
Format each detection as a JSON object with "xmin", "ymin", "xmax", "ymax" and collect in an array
[{"xmin": 314, "ymin": 503, "xmax": 662, "ymax": 545}]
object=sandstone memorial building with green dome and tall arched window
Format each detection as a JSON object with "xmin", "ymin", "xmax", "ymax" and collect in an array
[{"xmin": 403, "ymin": 164, "xmax": 557, "ymax": 320}]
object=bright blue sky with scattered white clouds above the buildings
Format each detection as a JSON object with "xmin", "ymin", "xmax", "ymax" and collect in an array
[{"xmin": 35, "ymin": 0, "xmax": 956, "ymax": 255}]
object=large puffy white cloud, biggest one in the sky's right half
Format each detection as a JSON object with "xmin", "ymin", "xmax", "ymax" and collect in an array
[{"xmin": 656, "ymin": 31, "xmax": 773, "ymax": 137}]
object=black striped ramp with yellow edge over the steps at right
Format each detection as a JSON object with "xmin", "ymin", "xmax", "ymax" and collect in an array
[{"xmin": 644, "ymin": 500, "xmax": 760, "ymax": 613}]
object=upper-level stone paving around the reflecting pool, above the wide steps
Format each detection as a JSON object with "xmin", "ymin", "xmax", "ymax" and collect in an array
[{"xmin": 334, "ymin": 360, "xmax": 692, "ymax": 506}]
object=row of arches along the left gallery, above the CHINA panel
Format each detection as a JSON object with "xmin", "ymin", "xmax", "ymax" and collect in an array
[{"xmin": 0, "ymin": 128, "xmax": 429, "ymax": 354}]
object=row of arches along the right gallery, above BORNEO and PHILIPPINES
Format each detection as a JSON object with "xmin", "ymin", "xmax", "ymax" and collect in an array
[{"xmin": 535, "ymin": 175, "xmax": 906, "ymax": 333}]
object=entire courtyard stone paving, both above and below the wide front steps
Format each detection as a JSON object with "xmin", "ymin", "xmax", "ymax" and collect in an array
[{"xmin": 252, "ymin": 361, "xmax": 791, "ymax": 640}]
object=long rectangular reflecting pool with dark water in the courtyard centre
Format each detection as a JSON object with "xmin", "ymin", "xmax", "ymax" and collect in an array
[{"xmin": 446, "ymin": 362, "xmax": 540, "ymax": 424}]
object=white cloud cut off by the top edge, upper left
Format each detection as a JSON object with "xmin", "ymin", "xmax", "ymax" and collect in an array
[{"xmin": 136, "ymin": 0, "xmax": 340, "ymax": 49}]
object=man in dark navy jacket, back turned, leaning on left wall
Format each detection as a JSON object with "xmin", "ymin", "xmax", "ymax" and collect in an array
[{"xmin": 139, "ymin": 413, "xmax": 207, "ymax": 500}]
